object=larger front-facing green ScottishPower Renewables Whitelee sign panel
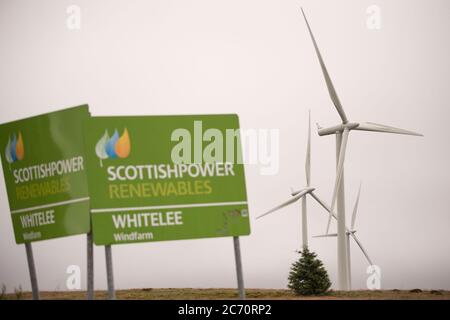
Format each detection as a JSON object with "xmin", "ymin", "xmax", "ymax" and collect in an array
[{"xmin": 85, "ymin": 115, "xmax": 250, "ymax": 245}]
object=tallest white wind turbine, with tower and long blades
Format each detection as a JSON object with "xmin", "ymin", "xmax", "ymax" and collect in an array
[{"xmin": 302, "ymin": 9, "xmax": 421, "ymax": 290}]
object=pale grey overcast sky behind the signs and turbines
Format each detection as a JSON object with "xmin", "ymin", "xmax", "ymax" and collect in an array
[{"xmin": 0, "ymin": 0, "xmax": 450, "ymax": 291}]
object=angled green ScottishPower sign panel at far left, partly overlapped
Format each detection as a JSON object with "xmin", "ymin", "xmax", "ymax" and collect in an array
[{"xmin": 0, "ymin": 105, "xmax": 90, "ymax": 243}]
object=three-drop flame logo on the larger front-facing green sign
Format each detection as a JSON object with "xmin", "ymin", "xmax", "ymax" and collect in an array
[{"xmin": 95, "ymin": 128, "xmax": 131, "ymax": 167}]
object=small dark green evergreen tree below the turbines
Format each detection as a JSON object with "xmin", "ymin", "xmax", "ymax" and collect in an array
[{"xmin": 288, "ymin": 248, "xmax": 331, "ymax": 295}]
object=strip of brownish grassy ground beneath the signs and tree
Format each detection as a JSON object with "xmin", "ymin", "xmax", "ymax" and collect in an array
[{"xmin": 2, "ymin": 288, "xmax": 450, "ymax": 300}]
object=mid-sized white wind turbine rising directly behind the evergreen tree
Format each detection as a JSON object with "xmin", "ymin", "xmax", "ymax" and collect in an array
[{"xmin": 256, "ymin": 112, "xmax": 321, "ymax": 249}]
